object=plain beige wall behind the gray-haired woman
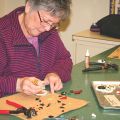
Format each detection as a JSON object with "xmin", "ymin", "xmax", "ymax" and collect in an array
[{"xmin": 0, "ymin": 0, "xmax": 109, "ymax": 62}]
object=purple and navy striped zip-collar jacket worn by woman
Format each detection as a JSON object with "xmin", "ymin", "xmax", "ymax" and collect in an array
[{"xmin": 0, "ymin": 7, "xmax": 72, "ymax": 97}]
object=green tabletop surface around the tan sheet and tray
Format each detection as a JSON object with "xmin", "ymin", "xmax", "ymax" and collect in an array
[{"xmin": 0, "ymin": 47, "xmax": 120, "ymax": 120}]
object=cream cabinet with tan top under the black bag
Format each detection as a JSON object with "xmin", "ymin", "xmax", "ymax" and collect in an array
[{"xmin": 72, "ymin": 30, "xmax": 120, "ymax": 64}]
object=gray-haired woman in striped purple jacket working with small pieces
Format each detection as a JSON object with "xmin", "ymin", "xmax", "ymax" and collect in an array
[{"xmin": 0, "ymin": 0, "xmax": 72, "ymax": 97}]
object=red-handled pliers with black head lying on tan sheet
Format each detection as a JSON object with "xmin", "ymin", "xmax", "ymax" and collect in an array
[{"xmin": 0, "ymin": 100, "xmax": 37, "ymax": 118}]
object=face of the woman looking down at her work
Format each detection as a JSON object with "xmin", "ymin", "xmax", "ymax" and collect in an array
[{"xmin": 23, "ymin": 2, "xmax": 60, "ymax": 36}]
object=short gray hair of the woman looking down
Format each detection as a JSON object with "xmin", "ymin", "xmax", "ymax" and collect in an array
[{"xmin": 26, "ymin": 0, "xmax": 71, "ymax": 20}]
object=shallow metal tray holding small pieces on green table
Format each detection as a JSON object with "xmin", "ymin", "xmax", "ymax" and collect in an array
[{"xmin": 92, "ymin": 81, "xmax": 120, "ymax": 109}]
